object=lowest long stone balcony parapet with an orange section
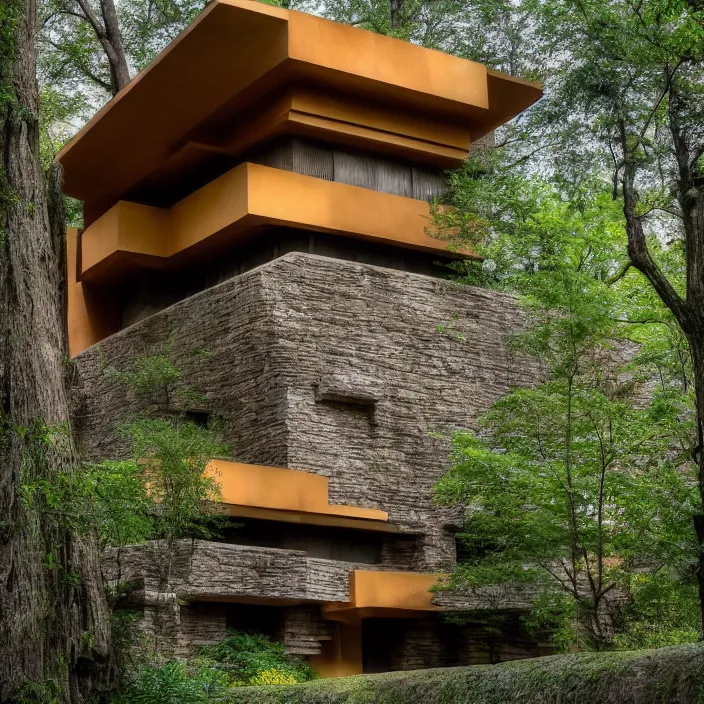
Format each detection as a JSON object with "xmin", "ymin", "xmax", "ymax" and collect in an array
[{"xmin": 103, "ymin": 540, "xmax": 539, "ymax": 622}]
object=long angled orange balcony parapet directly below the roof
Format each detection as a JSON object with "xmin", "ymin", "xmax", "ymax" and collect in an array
[{"xmin": 78, "ymin": 163, "xmax": 471, "ymax": 283}]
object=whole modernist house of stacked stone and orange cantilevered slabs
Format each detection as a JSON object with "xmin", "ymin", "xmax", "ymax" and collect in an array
[{"xmin": 59, "ymin": 0, "xmax": 541, "ymax": 676}]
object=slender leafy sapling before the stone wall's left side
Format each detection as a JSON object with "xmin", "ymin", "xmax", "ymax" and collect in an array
[{"xmin": 87, "ymin": 353, "xmax": 228, "ymax": 560}]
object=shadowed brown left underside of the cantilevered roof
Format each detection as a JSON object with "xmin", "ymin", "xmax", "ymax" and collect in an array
[{"xmin": 58, "ymin": 1, "xmax": 288, "ymax": 200}]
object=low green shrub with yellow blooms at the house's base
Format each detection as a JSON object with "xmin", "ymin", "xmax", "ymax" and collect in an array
[{"xmin": 200, "ymin": 631, "xmax": 315, "ymax": 684}]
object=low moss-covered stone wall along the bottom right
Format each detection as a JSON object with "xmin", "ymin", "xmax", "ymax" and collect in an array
[{"xmin": 224, "ymin": 645, "xmax": 704, "ymax": 704}]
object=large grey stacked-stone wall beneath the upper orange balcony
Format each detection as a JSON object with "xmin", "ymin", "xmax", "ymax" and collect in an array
[{"xmin": 75, "ymin": 253, "xmax": 540, "ymax": 570}]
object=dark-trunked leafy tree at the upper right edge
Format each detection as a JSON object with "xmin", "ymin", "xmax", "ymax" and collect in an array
[{"xmin": 468, "ymin": 0, "xmax": 704, "ymax": 619}]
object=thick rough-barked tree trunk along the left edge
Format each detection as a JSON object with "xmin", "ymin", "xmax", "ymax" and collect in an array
[{"xmin": 0, "ymin": 0, "xmax": 111, "ymax": 702}]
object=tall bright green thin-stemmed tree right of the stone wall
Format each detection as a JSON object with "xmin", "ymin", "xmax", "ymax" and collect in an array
[{"xmin": 437, "ymin": 174, "xmax": 696, "ymax": 648}]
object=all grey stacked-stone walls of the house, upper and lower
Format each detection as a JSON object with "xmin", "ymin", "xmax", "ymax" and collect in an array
[{"xmin": 80, "ymin": 253, "xmax": 540, "ymax": 669}]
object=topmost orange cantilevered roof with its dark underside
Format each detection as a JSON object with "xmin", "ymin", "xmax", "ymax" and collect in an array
[{"xmin": 58, "ymin": 0, "xmax": 541, "ymax": 220}]
